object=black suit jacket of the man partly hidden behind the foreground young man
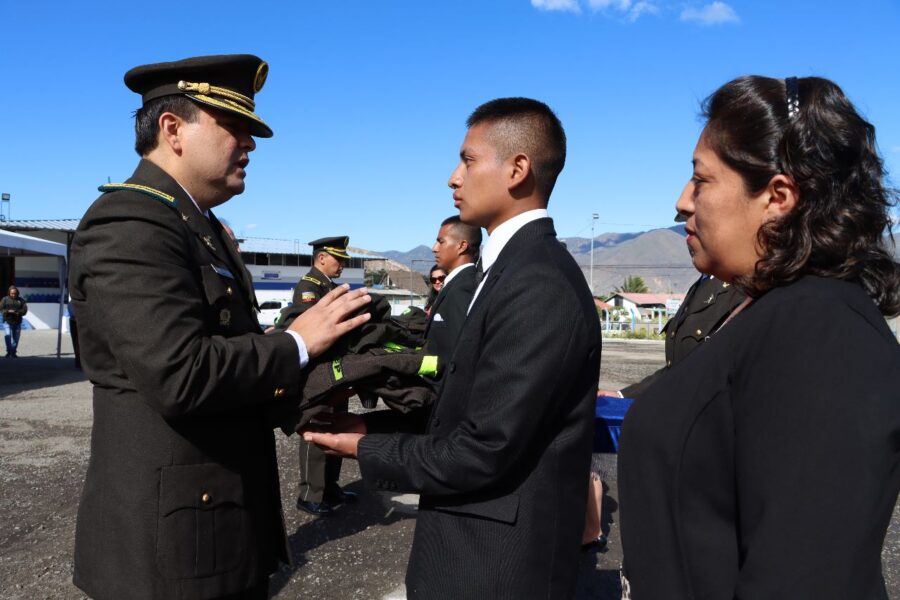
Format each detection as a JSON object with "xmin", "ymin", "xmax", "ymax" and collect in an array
[{"xmin": 425, "ymin": 265, "xmax": 478, "ymax": 364}]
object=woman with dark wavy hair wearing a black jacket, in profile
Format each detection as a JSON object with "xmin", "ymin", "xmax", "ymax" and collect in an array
[{"xmin": 619, "ymin": 77, "xmax": 900, "ymax": 600}]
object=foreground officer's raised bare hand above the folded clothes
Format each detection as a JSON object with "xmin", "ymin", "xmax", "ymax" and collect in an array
[{"xmin": 288, "ymin": 284, "xmax": 372, "ymax": 358}]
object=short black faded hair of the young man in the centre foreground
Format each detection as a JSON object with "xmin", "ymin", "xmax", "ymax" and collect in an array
[{"xmin": 466, "ymin": 98, "xmax": 566, "ymax": 200}]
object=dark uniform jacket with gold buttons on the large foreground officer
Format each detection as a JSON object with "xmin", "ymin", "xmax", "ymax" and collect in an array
[{"xmin": 69, "ymin": 161, "xmax": 301, "ymax": 600}]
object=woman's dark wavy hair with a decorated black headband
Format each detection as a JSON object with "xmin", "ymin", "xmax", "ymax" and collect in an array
[{"xmin": 703, "ymin": 76, "xmax": 900, "ymax": 315}]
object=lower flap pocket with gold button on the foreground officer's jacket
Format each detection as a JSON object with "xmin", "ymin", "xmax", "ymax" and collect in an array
[{"xmin": 156, "ymin": 464, "xmax": 250, "ymax": 579}]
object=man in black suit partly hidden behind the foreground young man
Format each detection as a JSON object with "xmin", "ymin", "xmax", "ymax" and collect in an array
[{"xmin": 425, "ymin": 215, "xmax": 481, "ymax": 364}]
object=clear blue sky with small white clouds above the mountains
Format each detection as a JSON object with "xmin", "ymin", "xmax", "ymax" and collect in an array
[{"xmin": 0, "ymin": 0, "xmax": 900, "ymax": 250}]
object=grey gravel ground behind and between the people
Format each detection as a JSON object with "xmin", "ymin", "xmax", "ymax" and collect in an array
[{"xmin": 0, "ymin": 331, "xmax": 900, "ymax": 600}]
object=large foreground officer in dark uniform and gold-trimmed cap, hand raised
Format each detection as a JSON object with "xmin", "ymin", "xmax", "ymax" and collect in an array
[{"xmin": 69, "ymin": 55, "xmax": 368, "ymax": 600}]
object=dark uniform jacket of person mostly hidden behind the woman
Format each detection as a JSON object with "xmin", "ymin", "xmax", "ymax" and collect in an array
[{"xmin": 621, "ymin": 277, "xmax": 745, "ymax": 398}]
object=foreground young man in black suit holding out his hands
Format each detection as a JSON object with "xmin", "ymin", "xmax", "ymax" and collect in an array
[{"xmin": 304, "ymin": 98, "xmax": 600, "ymax": 599}]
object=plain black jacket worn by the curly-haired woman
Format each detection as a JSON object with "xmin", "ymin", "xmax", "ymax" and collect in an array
[{"xmin": 619, "ymin": 277, "xmax": 900, "ymax": 600}]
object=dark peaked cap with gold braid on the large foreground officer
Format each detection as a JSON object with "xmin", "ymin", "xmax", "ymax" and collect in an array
[{"xmin": 125, "ymin": 54, "xmax": 272, "ymax": 137}]
